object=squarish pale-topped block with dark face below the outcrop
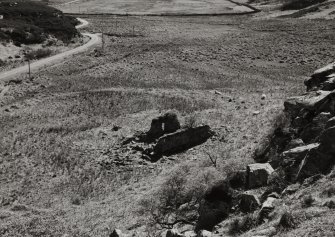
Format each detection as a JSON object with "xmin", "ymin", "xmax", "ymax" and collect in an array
[{"xmin": 247, "ymin": 163, "xmax": 274, "ymax": 189}]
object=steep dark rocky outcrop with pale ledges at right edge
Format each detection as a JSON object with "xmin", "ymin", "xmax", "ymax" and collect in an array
[{"xmin": 255, "ymin": 63, "xmax": 335, "ymax": 182}]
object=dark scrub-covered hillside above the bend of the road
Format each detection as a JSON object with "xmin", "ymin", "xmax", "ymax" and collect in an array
[{"xmin": 0, "ymin": 0, "xmax": 78, "ymax": 45}]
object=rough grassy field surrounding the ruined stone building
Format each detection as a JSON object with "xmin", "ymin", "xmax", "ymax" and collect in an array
[{"xmin": 0, "ymin": 13, "xmax": 335, "ymax": 237}]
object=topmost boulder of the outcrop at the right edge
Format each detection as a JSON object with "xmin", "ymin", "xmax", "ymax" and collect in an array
[{"xmin": 305, "ymin": 63, "xmax": 335, "ymax": 90}]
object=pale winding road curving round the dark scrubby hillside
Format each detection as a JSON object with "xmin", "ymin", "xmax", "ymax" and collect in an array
[{"xmin": 0, "ymin": 18, "xmax": 100, "ymax": 81}]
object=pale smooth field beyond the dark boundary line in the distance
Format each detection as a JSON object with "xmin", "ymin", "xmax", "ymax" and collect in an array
[{"xmin": 58, "ymin": 0, "xmax": 253, "ymax": 15}]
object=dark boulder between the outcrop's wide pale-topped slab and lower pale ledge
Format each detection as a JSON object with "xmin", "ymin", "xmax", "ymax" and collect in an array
[{"xmin": 300, "ymin": 112, "xmax": 332, "ymax": 143}]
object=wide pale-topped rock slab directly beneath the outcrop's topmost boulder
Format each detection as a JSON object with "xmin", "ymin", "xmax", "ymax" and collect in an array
[{"xmin": 284, "ymin": 91, "xmax": 335, "ymax": 118}]
